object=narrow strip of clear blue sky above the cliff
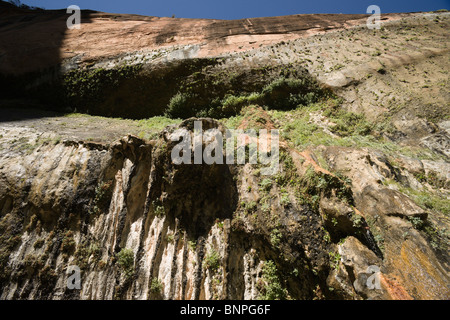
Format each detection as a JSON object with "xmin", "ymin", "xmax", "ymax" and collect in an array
[{"xmin": 18, "ymin": 0, "xmax": 450, "ymax": 19}]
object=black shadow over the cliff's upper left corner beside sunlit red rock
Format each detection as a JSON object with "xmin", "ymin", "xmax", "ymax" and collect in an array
[{"xmin": 0, "ymin": 1, "xmax": 93, "ymax": 121}]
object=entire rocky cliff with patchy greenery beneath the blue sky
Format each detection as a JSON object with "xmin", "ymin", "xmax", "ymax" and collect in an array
[{"xmin": 0, "ymin": 3, "xmax": 450, "ymax": 299}]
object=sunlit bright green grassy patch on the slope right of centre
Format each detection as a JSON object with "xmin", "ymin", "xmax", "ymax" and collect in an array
[{"xmin": 269, "ymin": 97, "xmax": 442, "ymax": 160}]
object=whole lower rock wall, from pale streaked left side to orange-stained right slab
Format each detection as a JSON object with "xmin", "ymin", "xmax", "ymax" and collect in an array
[{"xmin": 0, "ymin": 119, "xmax": 449, "ymax": 299}]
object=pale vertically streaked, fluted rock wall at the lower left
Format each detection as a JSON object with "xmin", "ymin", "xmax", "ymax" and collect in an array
[{"xmin": 0, "ymin": 120, "xmax": 327, "ymax": 299}]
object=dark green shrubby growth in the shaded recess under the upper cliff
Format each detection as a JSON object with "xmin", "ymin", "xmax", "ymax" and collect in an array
[{"xmin": 166, "ymin": 64, "xmax": 330, "ymax": 118}]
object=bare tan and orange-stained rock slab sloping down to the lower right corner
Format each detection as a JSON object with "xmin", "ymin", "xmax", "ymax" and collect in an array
[{"xmin": 324, "ymin": 148, "xmax": 448, "ymax": 299}]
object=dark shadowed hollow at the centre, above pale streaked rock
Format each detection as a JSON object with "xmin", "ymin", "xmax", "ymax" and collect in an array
[{"xmin": 150, "ymin": 118, "xmax": 238, "ymax": 240}]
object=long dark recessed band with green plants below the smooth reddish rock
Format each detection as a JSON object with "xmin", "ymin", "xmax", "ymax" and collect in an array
[{"xmin": 4, "ymin": 59, "xmax": 330, "ymax": 119}]
